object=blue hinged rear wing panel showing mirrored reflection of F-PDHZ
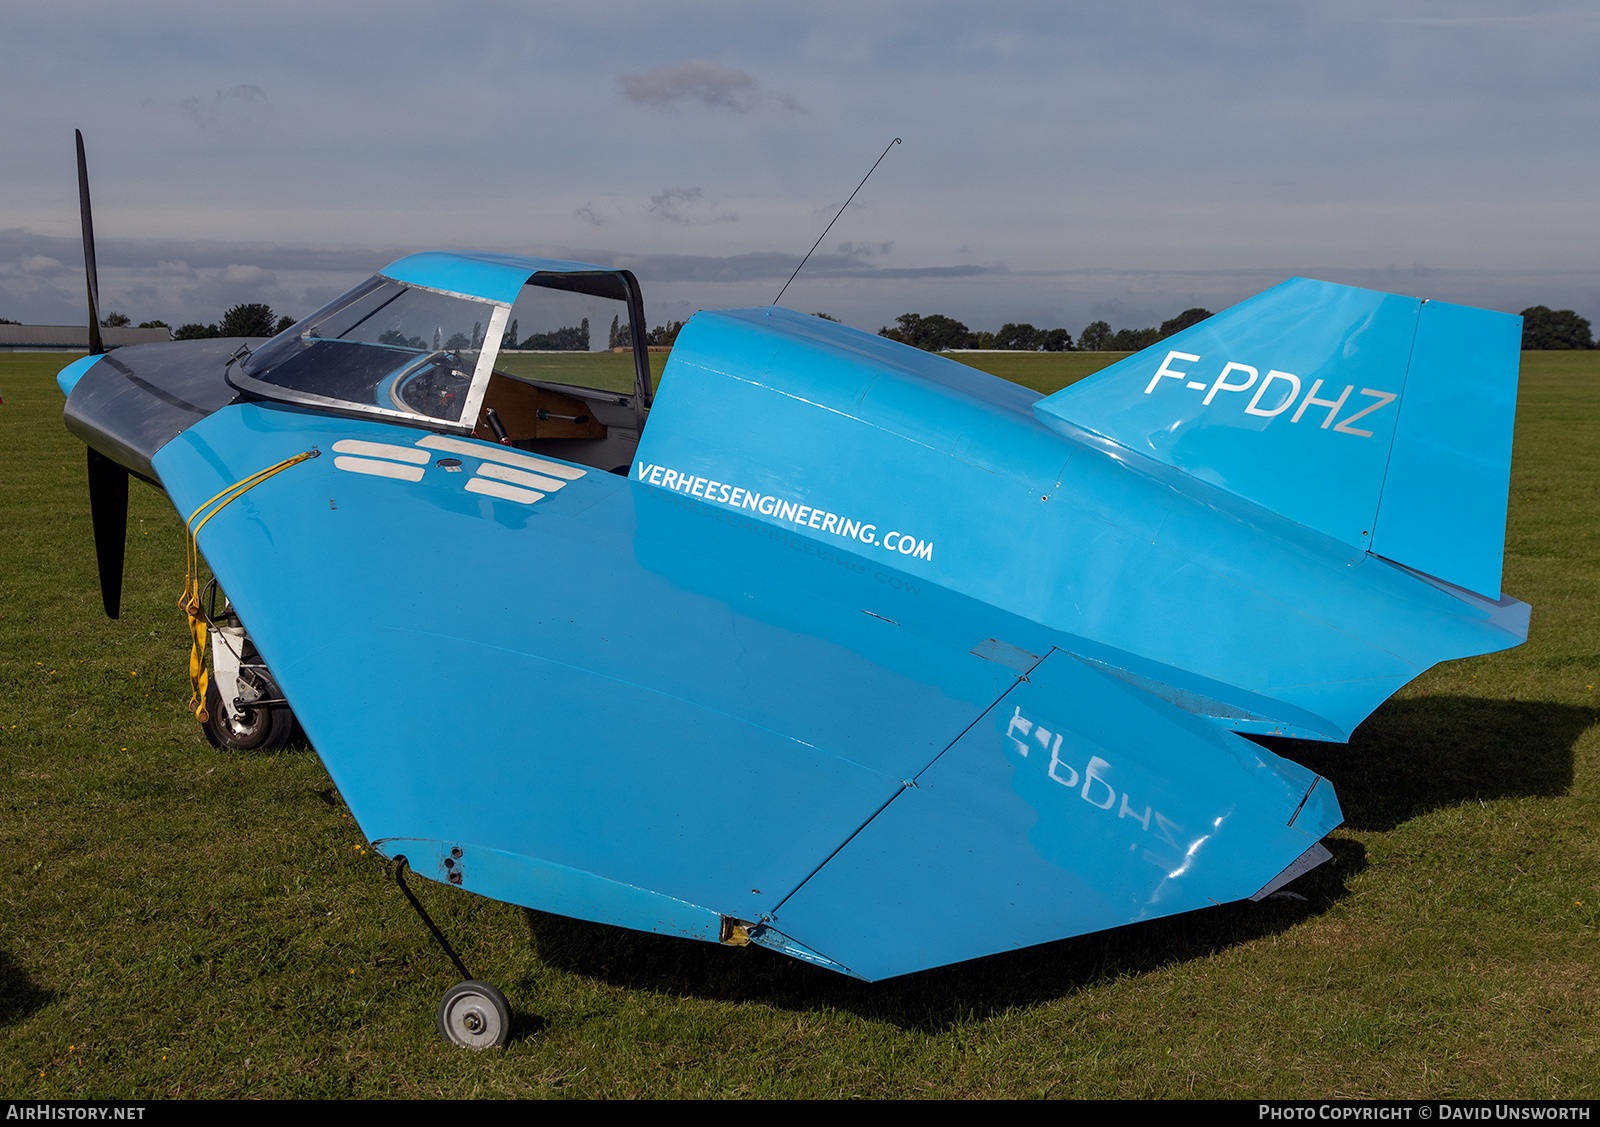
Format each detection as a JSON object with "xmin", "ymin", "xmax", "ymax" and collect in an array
[{"xmin": 768, "ymin": 650, "xmax": 1344, "ymax": 980}]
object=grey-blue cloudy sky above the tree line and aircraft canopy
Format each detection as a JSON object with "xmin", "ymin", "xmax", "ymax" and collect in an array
[{"xmin": 0, "ymin": 0, "xmax": 1600, "ymax": 336}]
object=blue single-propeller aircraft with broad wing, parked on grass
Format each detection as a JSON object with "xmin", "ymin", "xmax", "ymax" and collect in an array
[{"xmin": 59, "ymin": 138, "xmax": 1528, "ymax": 1045}]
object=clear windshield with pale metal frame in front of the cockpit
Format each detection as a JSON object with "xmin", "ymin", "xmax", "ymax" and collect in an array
[{"xmin": 242, "ymin": 277, "xmax": 496, "ymax": 423}]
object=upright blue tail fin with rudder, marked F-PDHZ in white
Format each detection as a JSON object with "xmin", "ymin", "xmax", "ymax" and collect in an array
[{"xmin": 1034, "ymin": 279, "xmax": 1522, "ymax": 599}]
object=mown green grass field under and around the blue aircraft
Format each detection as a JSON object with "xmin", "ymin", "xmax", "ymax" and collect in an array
[{"xmin": 0, "ymin": 352, "xmax": 1600, "ymax": 1100}]
